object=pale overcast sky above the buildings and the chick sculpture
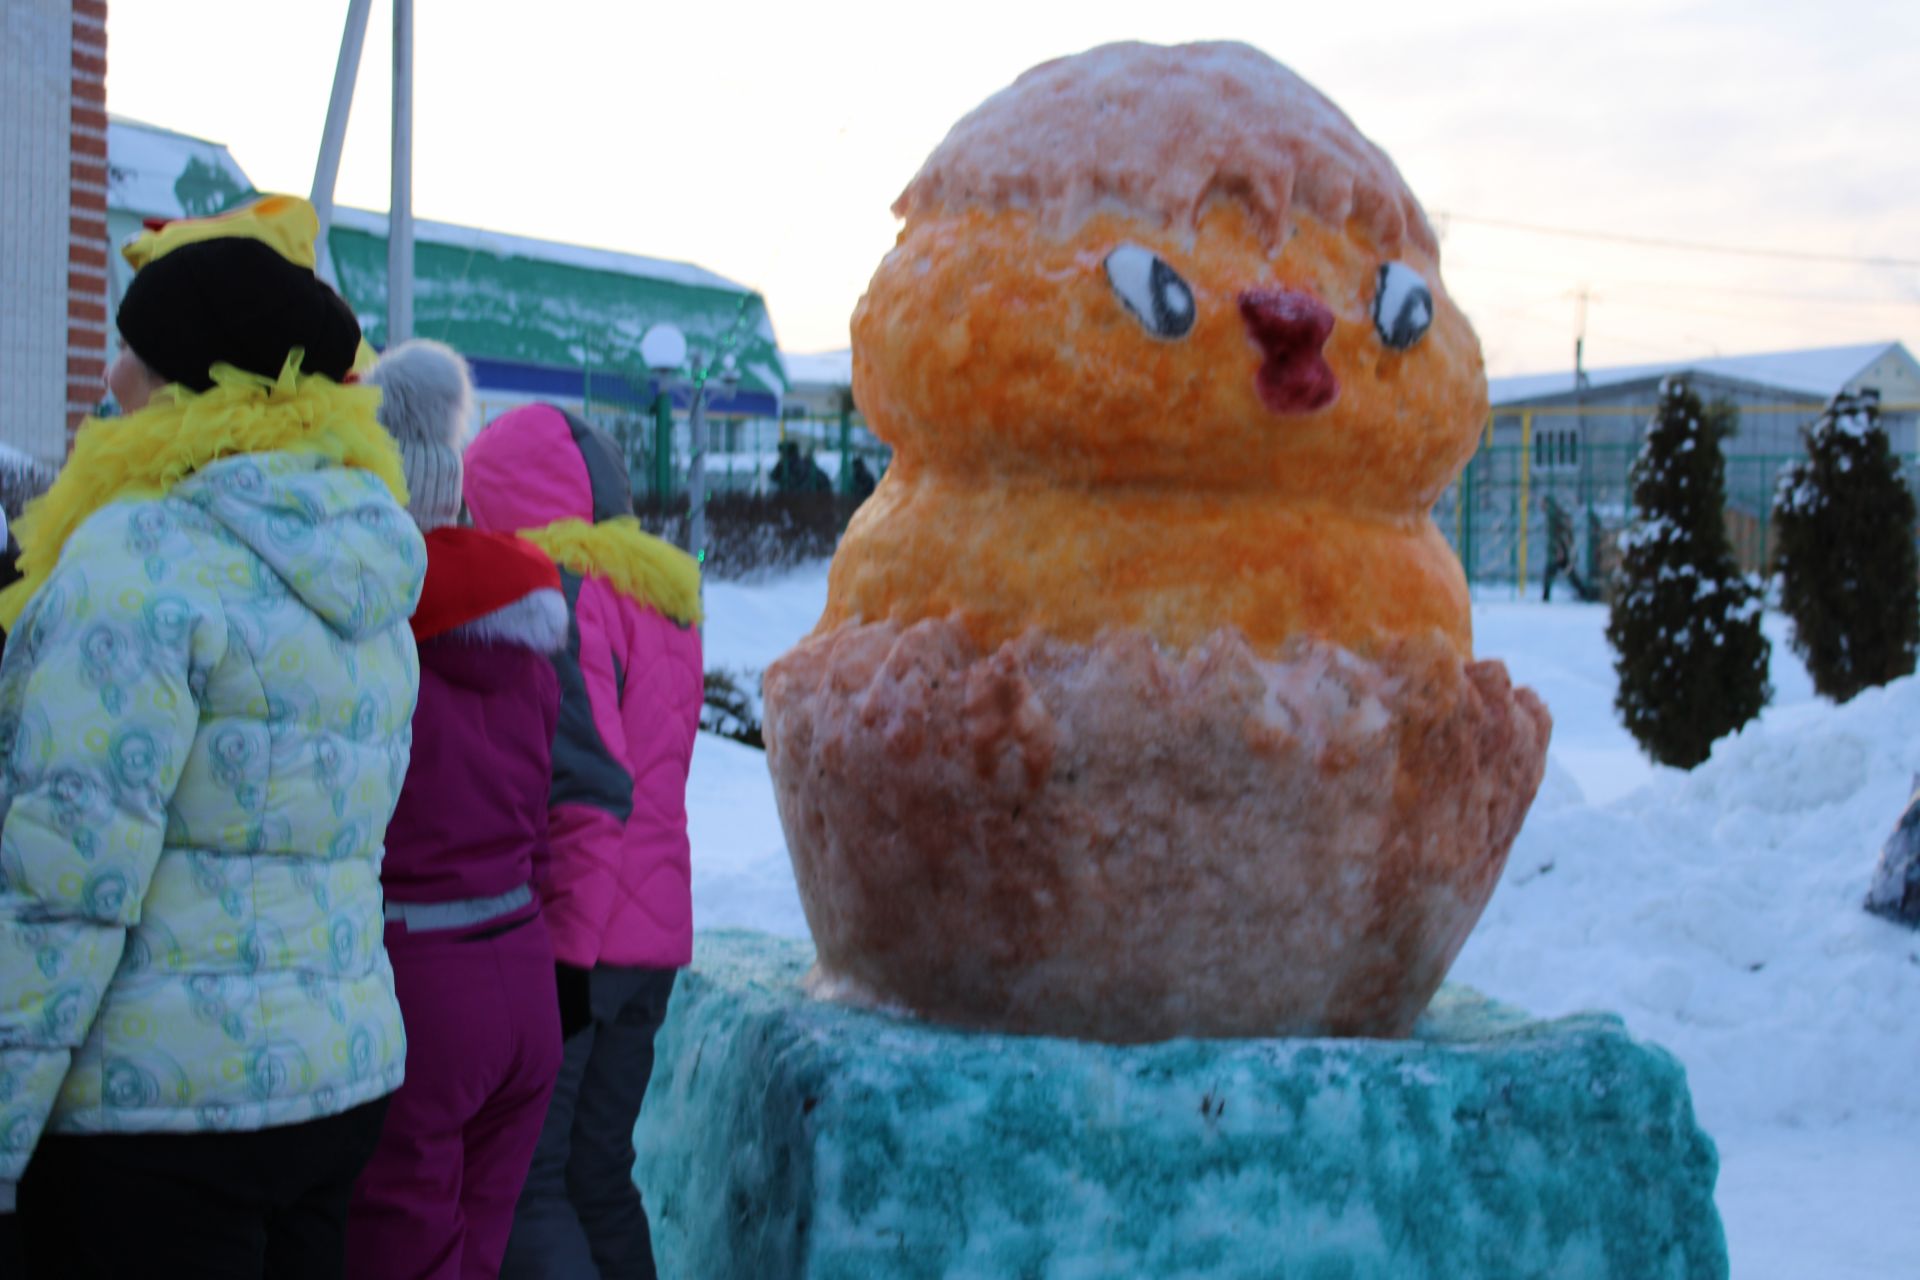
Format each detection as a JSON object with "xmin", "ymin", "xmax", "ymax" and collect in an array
[{"xmin": 108, "ymin": 0, "xmax": 1920, "ymax": 374}]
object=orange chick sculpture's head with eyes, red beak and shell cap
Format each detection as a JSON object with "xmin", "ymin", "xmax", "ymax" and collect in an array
[{"xmin": 854, "ymin": 44, "xmax": 1486, "ymax": 512}]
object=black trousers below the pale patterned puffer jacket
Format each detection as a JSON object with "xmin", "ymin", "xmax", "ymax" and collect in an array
[{"xmin": 19, "ymin": 1098, "xmax": 386, "ymax": 1280}]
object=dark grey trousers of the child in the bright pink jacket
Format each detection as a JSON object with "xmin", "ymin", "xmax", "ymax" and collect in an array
[{"xmin": 501, "ymin": 969, "xmax": 680, "ymax": 1280}]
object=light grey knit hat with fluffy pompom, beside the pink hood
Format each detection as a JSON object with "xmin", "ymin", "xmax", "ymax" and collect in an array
[{"xmin": 367, "ymin": 338, "xmax": 474, "ymax": 530}]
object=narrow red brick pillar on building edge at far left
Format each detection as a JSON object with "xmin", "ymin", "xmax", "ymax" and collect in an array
[{"xmin": 67, "ymin": 0, "xmax": 111, "ymax": 447}]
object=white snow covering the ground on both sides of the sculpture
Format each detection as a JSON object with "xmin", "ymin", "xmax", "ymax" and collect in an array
[{"xmin": 689, "ymin": 564, "xmax": 1920, "ymax": 1280}]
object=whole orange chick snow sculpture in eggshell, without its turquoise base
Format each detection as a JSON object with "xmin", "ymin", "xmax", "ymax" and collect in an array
[{"xmin": 766, "ymin": 44, "xmax": 1549, "ymax": 1042}]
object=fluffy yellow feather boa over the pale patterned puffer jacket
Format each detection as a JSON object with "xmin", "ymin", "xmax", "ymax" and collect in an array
[{"xmin": 0, "ymin": 347, "xmax": 407, "ymax": 629}]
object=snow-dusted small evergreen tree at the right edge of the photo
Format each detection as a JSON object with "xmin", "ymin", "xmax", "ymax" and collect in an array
[{"xmin": 1774, "ymin": 391, "xmax": 1920, "ymax": 702}]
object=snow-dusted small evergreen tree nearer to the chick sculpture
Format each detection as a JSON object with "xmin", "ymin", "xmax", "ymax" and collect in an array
[{"xmin": 1607, "ymin": 378, "xmax": 1772, "ymax": 770}]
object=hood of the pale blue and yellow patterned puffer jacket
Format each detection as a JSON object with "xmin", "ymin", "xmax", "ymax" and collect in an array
[{"xmin": 173, "ymin": 453, "xmax": 426, "ymax": 641}]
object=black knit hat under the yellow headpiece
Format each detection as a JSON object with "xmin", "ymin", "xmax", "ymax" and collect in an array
[{"xmin": 117, "ymin": 238, "xmax": 361, "ymax": 391}]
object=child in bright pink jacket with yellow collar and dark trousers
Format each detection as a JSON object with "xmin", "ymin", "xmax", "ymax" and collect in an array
[{"xmin": 465, "ymin": 405, "xmax": 703, "ymax": 1276}]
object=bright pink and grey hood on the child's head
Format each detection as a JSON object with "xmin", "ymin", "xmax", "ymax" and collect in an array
[{"xmin": 465, "ymin": 405, "xmax": 634, "ymax": 533}]
